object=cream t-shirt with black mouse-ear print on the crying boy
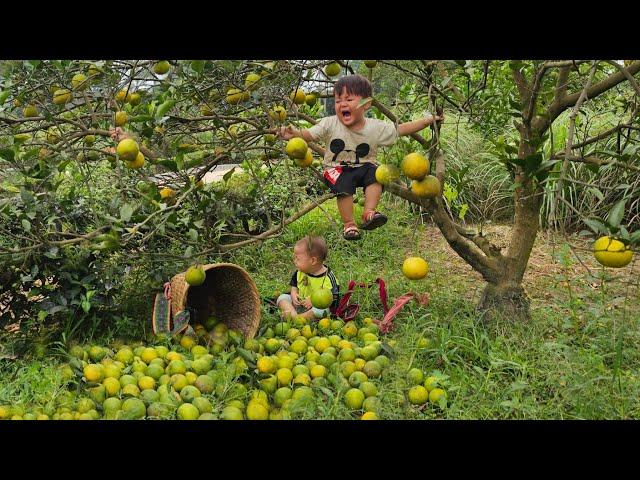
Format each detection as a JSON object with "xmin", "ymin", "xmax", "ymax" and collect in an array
[{"xmin": 308, "ymin": 115, "xmax": 398, "ymax": 167}]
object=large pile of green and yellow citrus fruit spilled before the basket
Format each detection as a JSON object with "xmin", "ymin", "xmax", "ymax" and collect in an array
[{"xmin": 0, "ymin": 317, "xmax": 392, "ymax": 420}]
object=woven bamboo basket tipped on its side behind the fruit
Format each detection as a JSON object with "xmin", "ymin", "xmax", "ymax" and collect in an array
[{"xmin": 171, "ymin": 263, "xmax": 260, "ymax": 339}]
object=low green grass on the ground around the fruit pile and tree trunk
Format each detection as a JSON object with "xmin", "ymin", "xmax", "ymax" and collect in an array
[{"xmin": 0, "ymin": 193, "xmax": 640, "ymax": 419}]
